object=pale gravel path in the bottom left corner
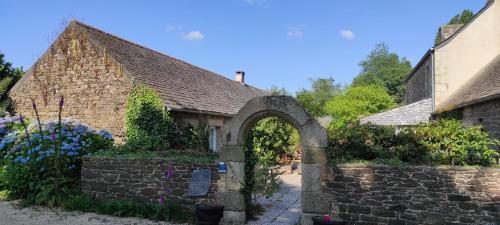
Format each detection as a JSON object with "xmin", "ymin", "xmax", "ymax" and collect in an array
[{"xmin": 0, "ymin": 201, "xmax": 188, "ymax": 225}]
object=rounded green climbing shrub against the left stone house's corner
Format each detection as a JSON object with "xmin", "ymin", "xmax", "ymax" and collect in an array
[{"xmin": 126, "ymin": 86, "xmax": 174, "ymax": 150}]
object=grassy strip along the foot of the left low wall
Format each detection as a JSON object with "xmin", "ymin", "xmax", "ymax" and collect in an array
[{"xmin": 61, "ymin": 195, "xmax": 188, "ymax": 222}]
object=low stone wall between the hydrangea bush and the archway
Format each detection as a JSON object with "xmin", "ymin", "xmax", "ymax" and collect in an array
[{"xmin": 81, "ymin": 157, "xmax": 219, "ymax": 208}]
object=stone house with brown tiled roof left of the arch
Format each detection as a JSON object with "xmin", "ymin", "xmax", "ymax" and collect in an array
[{"xmin": 10, "ymin": 21, "xmax": 267, "ymax": 151}]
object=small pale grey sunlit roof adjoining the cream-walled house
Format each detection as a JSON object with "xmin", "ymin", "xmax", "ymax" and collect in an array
[{"xmin": 361, "ymin": 98, "xmax": 432, "ymax": 126}]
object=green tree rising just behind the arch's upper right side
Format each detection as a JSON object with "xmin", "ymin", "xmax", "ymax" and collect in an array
[{"xmin": 296, "ymin": 77, "xmax": 343, "ymax": 117}]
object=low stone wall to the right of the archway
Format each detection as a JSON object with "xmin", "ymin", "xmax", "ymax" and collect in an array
[{"xmin": 320, "ymin": 165, "xmax": 500, "ymax": 225}]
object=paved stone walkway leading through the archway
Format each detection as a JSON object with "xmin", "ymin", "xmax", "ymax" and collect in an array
[{"xmin": 248, "ymin": 173, "xmax": 302, "ymax": 225}]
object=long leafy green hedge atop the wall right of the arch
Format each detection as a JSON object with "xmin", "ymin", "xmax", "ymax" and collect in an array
[{"xmin": 328, "ymin": 119, "xmax": 500, "ymax": 166}]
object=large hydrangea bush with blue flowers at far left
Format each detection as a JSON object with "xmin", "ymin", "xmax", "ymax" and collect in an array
[{"xmin": 0, "ymin": 97, "xmax": 113, "ymax": 206}]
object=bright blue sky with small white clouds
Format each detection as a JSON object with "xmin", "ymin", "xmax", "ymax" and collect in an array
[{"xmin": 0, "ymin": 0, "xmax": 485, "ymax": 93}]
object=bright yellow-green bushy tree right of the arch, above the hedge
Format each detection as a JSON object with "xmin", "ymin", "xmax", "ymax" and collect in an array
[{"xmin": 325, "ymin": 85, "xmax": 396, "ymax": 126}]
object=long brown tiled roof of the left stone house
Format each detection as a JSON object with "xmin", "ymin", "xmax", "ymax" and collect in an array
[{"xmin": 72, "ymin": 21, "xmax": 267, "ymax": 115}]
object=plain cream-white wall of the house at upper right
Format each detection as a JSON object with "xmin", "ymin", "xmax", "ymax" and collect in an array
[{"xmin": 434, "ymin": 0, "xmax": 500, "ymax": 112}]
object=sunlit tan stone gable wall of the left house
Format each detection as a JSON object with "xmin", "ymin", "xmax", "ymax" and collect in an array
[{"xmin": 10, "ymin": 26, "xmax": 132, "ymax": 139}]
